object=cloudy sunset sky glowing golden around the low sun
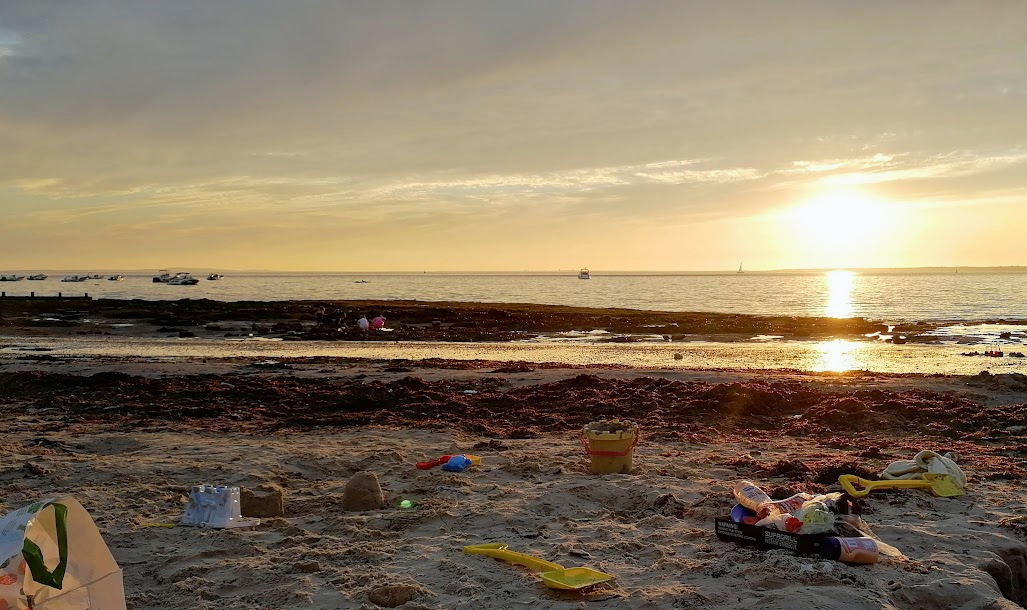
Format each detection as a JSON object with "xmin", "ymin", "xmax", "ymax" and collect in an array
[{"xmin": 0, "ymin": 0, "xmax": 1027, "ymax": 271}]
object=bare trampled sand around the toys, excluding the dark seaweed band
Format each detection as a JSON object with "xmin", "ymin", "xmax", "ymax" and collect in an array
[{"xmin": 0, "ymin": 353, "xmax": 1027, "ymax": 610}]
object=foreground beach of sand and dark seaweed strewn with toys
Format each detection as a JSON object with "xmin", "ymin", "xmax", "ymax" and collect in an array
[{"xmin": 0, "ymin": 351, "xmax": 1027, "ymax": 610}]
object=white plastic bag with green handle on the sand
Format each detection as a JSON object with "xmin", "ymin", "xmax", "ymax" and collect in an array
[{"xmin": 0, "ymin": 496, "xmax": 125, "ymax": 610}]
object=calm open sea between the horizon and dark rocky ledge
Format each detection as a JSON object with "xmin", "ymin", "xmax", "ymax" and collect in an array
[{"xmin": 0, "ymin": 271, "xmax": 1027, "ymax": 321}]
